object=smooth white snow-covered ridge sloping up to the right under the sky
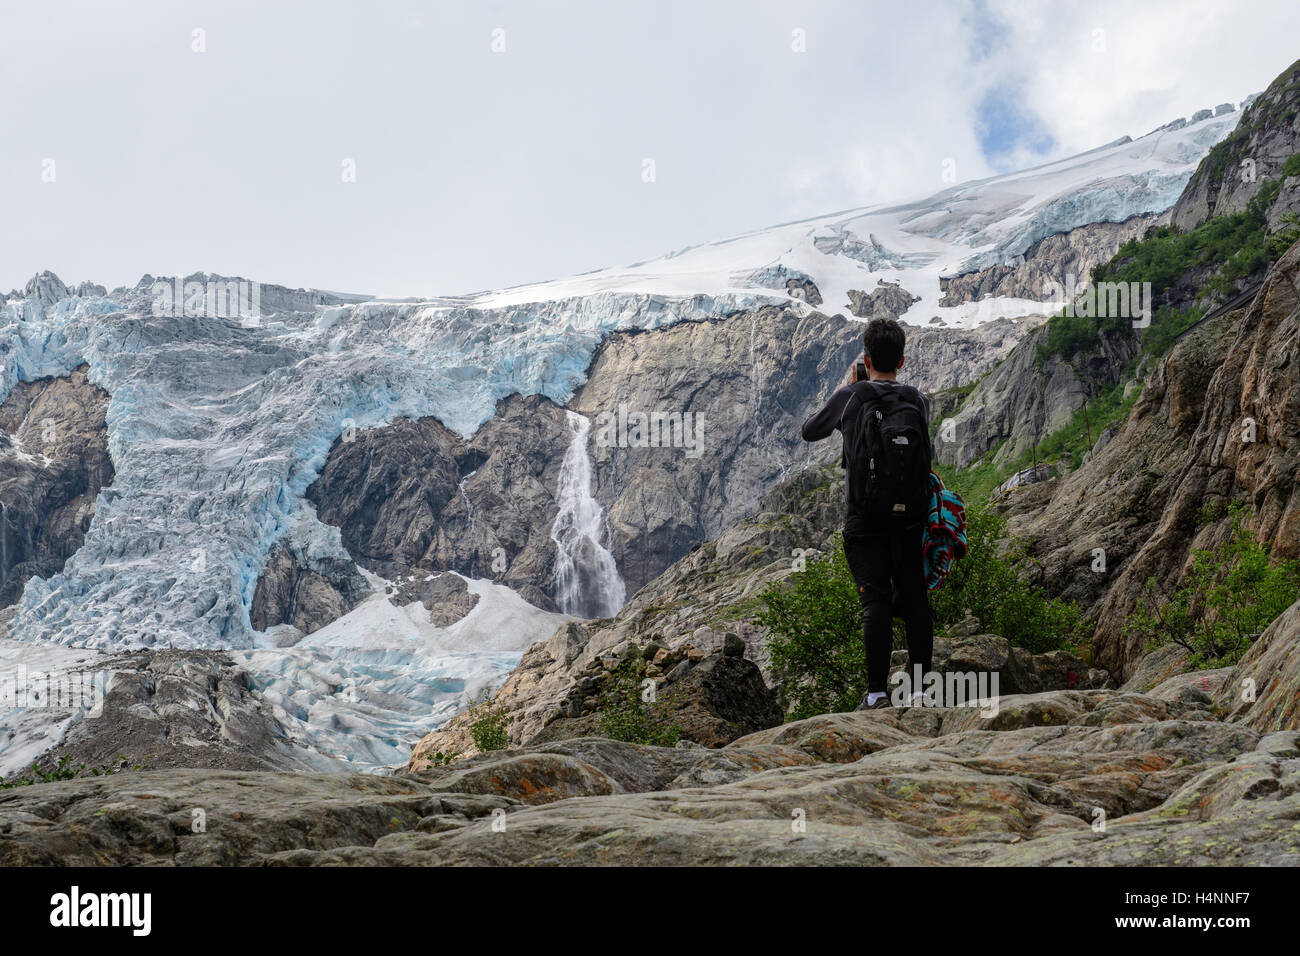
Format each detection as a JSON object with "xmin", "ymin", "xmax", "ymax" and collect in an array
[{"xmin": 454, "ymin": 108, "xmax": 1240, "ymax": 326}]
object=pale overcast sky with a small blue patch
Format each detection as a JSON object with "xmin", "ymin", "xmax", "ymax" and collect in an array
[{"xmin": 0, "ymin": 0, "xmax": 1300, "ymax": 295}]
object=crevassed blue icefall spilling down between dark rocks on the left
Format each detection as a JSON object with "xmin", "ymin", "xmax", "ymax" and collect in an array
[{"xmin": 0, "ymin": 284, "xmax": 771, "ymax": 648}]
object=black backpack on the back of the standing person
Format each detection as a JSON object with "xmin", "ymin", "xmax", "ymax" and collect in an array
[{"xmin": 842, "ymin": 381, "xmax": 931, "ymax": 524}]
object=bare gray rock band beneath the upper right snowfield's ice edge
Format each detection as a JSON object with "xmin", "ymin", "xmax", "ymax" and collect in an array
[{"xmin": 939, "ymin": 213, "xmax": 1169, "ymax": 306}]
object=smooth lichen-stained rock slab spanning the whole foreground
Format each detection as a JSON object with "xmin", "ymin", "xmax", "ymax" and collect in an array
[{"xmin": 0, "ymin": 691, "xmax": 1300, "ymax": 865}]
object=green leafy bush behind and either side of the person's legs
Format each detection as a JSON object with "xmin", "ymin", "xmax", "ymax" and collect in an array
[{"xmin": 757, "ymin": 506, "xmax": 1084, "ymax": 721}]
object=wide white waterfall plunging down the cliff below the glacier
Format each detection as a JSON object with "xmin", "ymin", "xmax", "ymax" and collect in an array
[{"xmin": 551, "ymin": 411, "xmax": 628, "ymax": 618}]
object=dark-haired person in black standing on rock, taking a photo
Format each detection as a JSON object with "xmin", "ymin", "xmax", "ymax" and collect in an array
[{"xmin": 803, "ymin": 319, "xmax": 935, "ymax": 710}]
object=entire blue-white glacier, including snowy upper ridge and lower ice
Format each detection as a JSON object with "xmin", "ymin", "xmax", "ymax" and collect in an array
[{"xmin": 0, "ymin": 104, "xmax": 1239, "ymax": 765}]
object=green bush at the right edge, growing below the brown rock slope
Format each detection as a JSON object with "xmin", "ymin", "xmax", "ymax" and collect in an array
[{"xmin": 1126, "ymin": 506, "xmax": 1300, "ymax": 669}]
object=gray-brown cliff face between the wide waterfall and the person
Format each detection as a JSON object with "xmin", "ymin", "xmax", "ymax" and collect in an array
[{"xmin": 571, "ymin": 308, "xmax": 861, "ymax": 593}]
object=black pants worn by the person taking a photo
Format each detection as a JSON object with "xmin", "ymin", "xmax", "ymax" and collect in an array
[{"xmin": 844, "ymin": 524, "xmax": 935, "ymax": 693}]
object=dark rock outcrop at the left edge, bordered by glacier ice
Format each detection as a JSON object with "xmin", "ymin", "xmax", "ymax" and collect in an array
[{"xmin": 0, "ymin": 366, "xmax": 113, "ymax": 607}]
